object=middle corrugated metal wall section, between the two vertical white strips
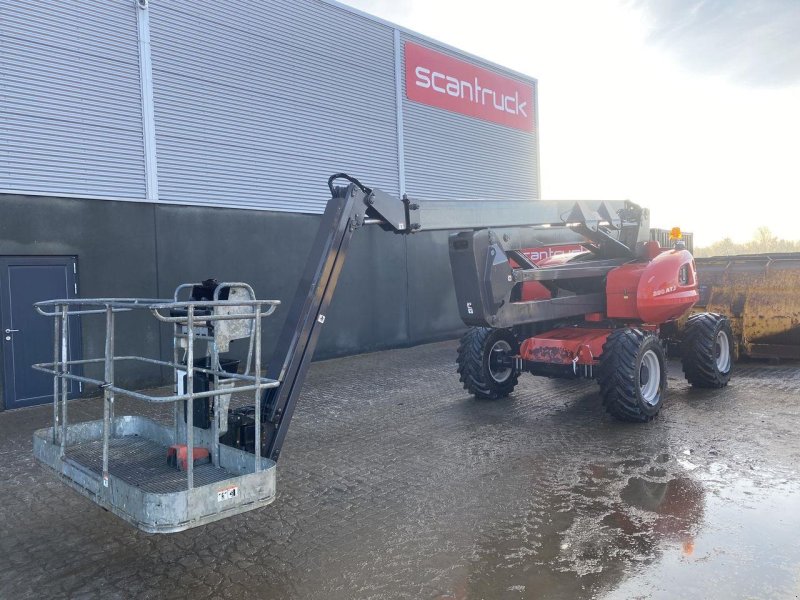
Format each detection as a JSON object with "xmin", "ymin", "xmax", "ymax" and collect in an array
[{"xmin": 150, "ymin": 0, "xmax": 398, "ymax": 213}]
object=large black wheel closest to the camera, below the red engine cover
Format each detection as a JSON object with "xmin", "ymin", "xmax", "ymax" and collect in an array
[{"xmin": 597, "ymin": 328, "xmax": 667, "ymax": 423}]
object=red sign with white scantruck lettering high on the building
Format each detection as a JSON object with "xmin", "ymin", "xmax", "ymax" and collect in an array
[{"xmin": 405, "ymin": 42, "xmax": 534, "ymax": 131}]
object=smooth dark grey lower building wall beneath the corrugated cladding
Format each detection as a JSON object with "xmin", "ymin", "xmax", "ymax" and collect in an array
[{"xmin": 0, "ymin": 195, "xmax": 463, "ymax": 408}]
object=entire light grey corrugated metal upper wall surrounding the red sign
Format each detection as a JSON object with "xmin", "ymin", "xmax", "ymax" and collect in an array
[{"xmin": 0, "ymin": 0, "xmax": 539, "ymax": 213}]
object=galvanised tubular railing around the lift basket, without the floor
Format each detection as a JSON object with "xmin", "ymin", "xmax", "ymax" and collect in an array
[{"xmin": 33, "ymin": 283, "xmax": 280, "ymax": 490}]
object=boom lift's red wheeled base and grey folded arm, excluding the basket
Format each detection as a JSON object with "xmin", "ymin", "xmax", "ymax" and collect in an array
[{"xmin": 262, "ymin": 174, "xmax": 733, "ymax": 460}]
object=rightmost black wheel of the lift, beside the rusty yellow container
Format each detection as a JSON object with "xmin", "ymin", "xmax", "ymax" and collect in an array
[{"xmin": 681, "ymin": 313, "xmax": 733, "ymax": 389}]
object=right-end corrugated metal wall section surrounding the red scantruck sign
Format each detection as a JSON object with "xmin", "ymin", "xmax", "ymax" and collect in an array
[{"xmin": 401, "ymin": 34, "xmax": 539, "ymax": 200}]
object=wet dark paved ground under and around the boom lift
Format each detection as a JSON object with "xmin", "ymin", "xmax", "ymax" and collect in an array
[{"xmin": 0, "ymin": 342, "xmax": 800, "ymax": 600}]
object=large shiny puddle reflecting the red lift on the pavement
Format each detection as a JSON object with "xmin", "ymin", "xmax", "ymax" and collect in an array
[{"xmin": 441, "ymin": 457, "xmax": 800, "ymax": 599}]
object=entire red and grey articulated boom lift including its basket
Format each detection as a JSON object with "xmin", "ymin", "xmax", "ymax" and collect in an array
[{"xmin": 34, "ymin": 173, "xmax": 733, "ymax": 532}]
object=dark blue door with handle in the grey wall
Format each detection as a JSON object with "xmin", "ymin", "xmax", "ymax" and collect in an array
[{"xmin": 0, "ymin": 256, "xmax": 81, "ymax": 408}]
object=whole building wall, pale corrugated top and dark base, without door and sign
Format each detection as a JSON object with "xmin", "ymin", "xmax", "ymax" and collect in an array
[{"xmin": 0, "ymin": 0, "xmax": 539, "ymax": 408}]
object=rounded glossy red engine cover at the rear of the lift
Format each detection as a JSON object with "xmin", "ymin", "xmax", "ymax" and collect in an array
[{"xmin": 606, "ymin": 250, "xmax": 700, "ymax": 323}]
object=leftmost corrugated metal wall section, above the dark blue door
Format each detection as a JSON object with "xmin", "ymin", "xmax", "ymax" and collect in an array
[{"xmin": 0, "ymin": 0, "xmax": 144, "ymax": 198}]
